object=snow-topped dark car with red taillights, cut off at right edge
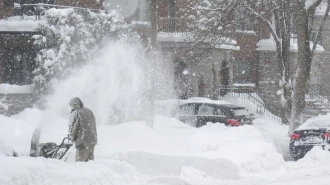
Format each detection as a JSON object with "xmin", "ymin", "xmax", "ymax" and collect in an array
[{"xmin": 290, "ymin": 115, "xmax": 330, "ymax": 159}]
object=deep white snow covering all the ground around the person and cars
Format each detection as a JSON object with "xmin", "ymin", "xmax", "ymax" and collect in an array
[{"xmin": 0, "ymin": 109, "xmax": 330, "ymax": 185}]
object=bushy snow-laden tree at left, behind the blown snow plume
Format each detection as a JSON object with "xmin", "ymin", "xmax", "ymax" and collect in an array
[{"xmin": 33, "ymin": 8, "xmax": 127, "ymax": 97}]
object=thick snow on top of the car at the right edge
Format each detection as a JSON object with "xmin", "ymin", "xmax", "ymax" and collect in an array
[{"xmin": 296, "ymin": 114, "xmax": 330, "ymax": 130}]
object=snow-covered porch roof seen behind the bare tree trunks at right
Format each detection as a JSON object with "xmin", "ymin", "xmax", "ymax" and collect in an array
[{"xmin": 256, "ymin": 39, "xmax": 325, "ymax": 53}]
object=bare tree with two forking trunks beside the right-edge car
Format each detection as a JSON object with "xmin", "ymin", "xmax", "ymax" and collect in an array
[{"xmin": 245, "ymin": 0, "xmax": 330, "ymax": 133}]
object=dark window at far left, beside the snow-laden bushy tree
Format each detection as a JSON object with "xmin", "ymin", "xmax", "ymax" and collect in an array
[{"xmin": 4, "ymin": 48, "xmax": 36, "ymax": 85}]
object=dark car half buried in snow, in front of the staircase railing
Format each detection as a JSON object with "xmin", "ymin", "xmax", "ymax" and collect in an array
[{"xmin": 175, "ymin": 101, "xmax": 252, "ymax": 127}]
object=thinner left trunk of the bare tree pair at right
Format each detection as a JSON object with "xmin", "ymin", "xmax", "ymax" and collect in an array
[{"xmin": 244, "ymin": 0, "xmax": 292, "ymax": 124}]
